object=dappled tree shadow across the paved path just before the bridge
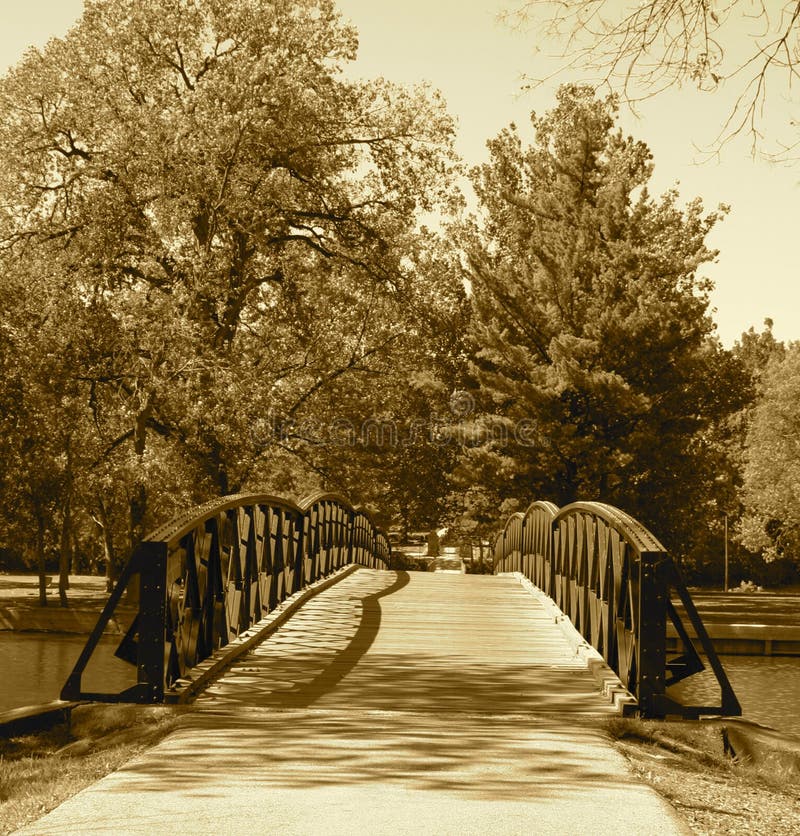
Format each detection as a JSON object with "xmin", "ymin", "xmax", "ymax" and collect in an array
[{"xmin": 117, "ymin": 709, "xmax": 630, "ymax": 801}]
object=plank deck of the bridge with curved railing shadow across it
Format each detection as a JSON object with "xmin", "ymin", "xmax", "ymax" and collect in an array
[{"xmin": 198, "ymin": 570, "xmax": 614, "ymax": 715}]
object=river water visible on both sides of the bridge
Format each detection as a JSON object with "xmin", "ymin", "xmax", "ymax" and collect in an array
[{"xmin": 0, "ymin": 632, "xmax": 800, "ymax": 734}]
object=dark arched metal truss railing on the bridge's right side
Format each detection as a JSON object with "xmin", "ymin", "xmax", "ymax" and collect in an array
[{"xmin": 494, "ymin": 502, "xmax": 741, "ymax": 717}]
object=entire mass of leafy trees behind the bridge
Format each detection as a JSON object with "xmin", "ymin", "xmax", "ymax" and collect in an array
[{"xmin": 0, "ymin": 0, "xmax": 800, "ymax": 605}]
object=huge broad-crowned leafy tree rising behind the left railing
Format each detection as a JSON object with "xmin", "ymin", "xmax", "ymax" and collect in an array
[{"xmin": 0, "ymin": 0, "xmax": 462, "ymax": 576}]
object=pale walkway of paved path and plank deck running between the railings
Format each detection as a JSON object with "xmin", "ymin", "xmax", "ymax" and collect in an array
[{"xmin": 19, "ymin": 570, "xmax": 689, "ymax": 836}]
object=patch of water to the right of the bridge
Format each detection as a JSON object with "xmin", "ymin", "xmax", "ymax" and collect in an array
[{"xmin": 669, "ymin": 656, "xmax": 800, "ymax": 734}]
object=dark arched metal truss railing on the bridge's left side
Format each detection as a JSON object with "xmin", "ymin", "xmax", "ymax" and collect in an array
[{"xmin": 61, "ymin": 493, "xmax": 391, "ymax": 703}]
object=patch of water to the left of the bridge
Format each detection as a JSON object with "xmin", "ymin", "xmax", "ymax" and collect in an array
[{"xmin": 0, "ymin": 632, "xmax": 136, "ymax": 711}]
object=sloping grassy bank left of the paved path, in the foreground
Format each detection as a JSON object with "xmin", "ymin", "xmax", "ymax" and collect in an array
[{"xmin": 0, "ymin": 704, "xmax": 186, "ymax": 834}]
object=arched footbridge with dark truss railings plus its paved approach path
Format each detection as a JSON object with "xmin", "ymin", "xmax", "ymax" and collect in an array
[{"xmin": 28, "ymin": 495, "xmax": 739, "ymax": 834}]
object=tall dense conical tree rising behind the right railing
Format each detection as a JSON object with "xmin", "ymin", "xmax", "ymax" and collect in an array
[{"xmin": 461, "ymin": 85, "xmax": 746, "ymax": 553}]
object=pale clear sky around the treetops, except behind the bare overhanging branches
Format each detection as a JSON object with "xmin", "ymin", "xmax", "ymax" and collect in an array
[{"xmin": 0, "ymin": 0, "xmax": 800, "ymax": 346}]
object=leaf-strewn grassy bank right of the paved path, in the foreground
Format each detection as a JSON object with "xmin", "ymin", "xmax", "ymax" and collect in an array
[{"xmin": 607, "ymin": 718, "xmax": 800, "ymax": 836}]
